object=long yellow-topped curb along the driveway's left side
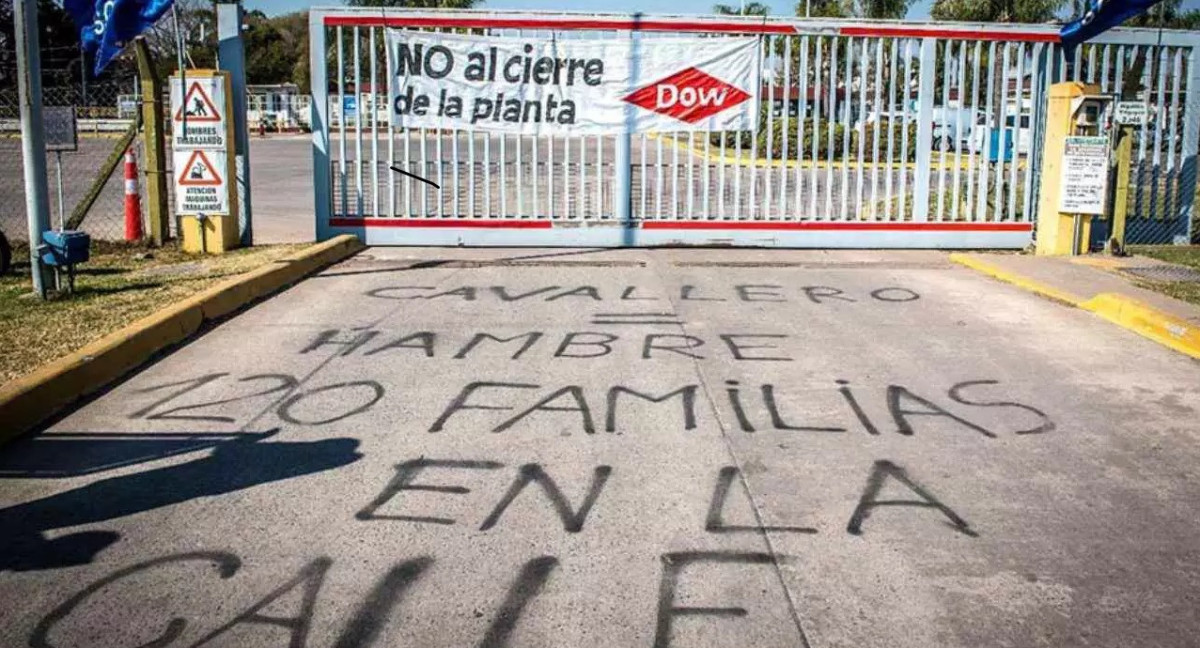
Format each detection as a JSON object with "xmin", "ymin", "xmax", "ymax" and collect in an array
[{"xmin": 0, "ymin": 234, "xmax": 364, "ymax": 444}]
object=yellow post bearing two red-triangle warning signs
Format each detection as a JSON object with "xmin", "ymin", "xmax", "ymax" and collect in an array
[{"xmin": 169, "ymin": 70, "xmax": 239, "ymax": 253}]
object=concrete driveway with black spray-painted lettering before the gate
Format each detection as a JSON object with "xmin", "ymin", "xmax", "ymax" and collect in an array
[{"xmin": 0, "ymin": 248, "xmax": 1200, "ymax": 648}]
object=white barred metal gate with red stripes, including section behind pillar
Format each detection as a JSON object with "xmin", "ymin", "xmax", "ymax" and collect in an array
[{"xmin": 310, "ymin": 8, "xmax": 1200, "ymax": 248}]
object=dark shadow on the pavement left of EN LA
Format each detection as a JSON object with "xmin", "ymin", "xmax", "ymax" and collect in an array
[{"xmin": 0, "ymin": 431, "xmax": 362, "ymax": 571}]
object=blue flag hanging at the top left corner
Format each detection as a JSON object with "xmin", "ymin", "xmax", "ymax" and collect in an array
[{"xmin": 62, "ymin": 0, "xmax": 175, "ymax": 76}]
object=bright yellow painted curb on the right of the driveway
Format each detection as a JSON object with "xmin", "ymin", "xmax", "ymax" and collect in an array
[{"xmin": 950, "ymin": 252, "xmax": 1200, "ymax": 360}]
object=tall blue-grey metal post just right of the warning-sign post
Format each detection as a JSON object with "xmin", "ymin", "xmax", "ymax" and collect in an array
[{"xmin": 217, "ymin": 2, "xmax": 256, "ymax": 247}]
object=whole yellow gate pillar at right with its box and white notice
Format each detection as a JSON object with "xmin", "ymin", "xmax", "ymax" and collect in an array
[{"xmin": 1037, "ymin": 82, "xmax": 1112, "ymax": 256}]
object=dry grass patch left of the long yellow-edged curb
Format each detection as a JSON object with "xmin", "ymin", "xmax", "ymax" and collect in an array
[{"xmin": 0, "ymin": 241, "xmax": 302, "ymax": 384}]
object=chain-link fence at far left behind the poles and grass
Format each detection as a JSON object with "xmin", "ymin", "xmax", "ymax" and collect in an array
[{"xmin": 0, "ymin": 78, "xmax": 169, "ymax": 241}]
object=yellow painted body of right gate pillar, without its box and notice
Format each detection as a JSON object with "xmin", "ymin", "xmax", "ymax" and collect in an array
[{"xmin": 1037, "ymin": 82, "xmax": 1100, "ymax": 256}]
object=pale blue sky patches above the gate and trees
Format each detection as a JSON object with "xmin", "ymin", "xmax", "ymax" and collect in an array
[{"xmin": 244, "ymin": 0, "xmax": 1200, "ymax": 20}]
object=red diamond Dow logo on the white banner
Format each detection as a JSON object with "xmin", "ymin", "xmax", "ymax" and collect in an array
[{"xmin": 624, "ymin": 67, "xmax": 750, "ymax": 124}]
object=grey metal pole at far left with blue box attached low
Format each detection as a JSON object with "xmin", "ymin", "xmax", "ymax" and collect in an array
[{"xmin": 12, "ymin": 0, "xmax": 50, "ymax": 298}]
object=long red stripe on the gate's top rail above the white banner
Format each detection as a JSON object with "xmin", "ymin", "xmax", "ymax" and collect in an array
[{"xmin": 325, "ymin": 16, "xmax": 796, "ymax": 34}]
